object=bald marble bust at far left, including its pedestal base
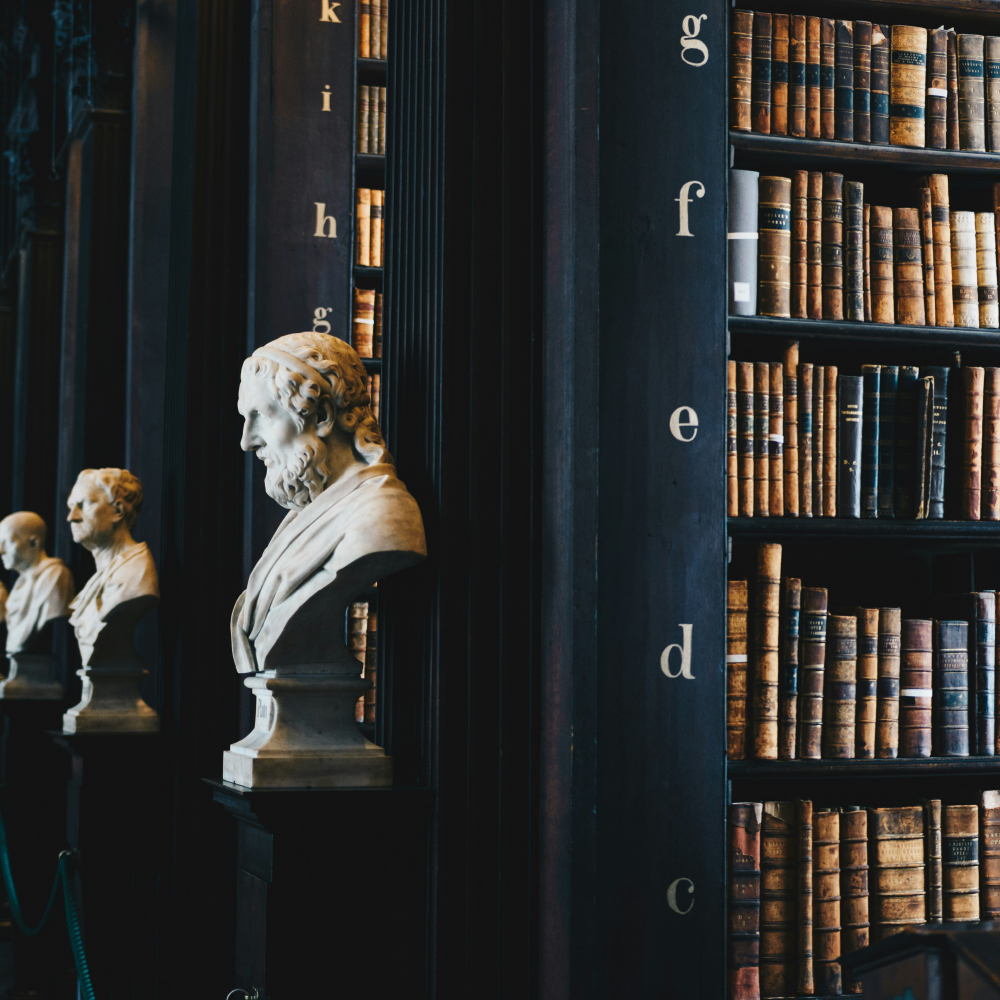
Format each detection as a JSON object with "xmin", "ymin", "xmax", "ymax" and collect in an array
[{"xmin": 0, "ymin": 511, "xmax": 74, "ymax": 699}]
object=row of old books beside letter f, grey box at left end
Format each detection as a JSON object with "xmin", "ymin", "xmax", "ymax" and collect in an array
[{"xmin": 729, "ymin": 170, "xmax": 1000, "ymax": 329}]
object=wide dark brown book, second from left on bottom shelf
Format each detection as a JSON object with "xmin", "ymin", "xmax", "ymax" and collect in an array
[{"xmin": 760, "ymin": 802, "xmax": 798, "ymax": 997}]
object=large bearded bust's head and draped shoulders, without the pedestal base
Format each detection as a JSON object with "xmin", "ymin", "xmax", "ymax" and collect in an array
[{"xmin": 231, "ymin": 333, "xmax": 427, "ymax": 673}]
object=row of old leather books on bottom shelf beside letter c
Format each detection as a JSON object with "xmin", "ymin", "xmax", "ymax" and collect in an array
[{"xmin": 728, "ymin": 791, "xmax": 1000, "ymax": 1000}]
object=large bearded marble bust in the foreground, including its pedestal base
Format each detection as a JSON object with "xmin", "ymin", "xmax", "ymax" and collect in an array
[{"xmin": 223, "ymin": 333, "xmax": 427, "ymax": 786}]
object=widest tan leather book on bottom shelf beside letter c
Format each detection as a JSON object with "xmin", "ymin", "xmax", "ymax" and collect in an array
[{"xmin": 868, "ymin": 806, "xmax": 925, "ymax": 944}]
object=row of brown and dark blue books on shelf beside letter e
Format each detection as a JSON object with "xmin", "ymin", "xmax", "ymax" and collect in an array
[{"xmin": 726, "ymin": 350, "xmax": 1000, "ymax": 521}]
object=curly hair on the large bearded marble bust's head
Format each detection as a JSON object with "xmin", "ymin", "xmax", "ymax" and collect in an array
[{"xmin": 241, "ymin": 331, "xmax": 392, "ymax": 465}]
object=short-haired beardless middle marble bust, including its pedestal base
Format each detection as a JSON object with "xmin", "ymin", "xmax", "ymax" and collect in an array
[{"xmin": 63, "ymin": 469, "xmax": 160, "ymax": 732}]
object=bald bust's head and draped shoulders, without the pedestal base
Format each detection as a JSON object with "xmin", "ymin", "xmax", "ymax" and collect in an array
[{"xmin": 0, "ymin": 510, "xmax": 75, "ymax": 653}]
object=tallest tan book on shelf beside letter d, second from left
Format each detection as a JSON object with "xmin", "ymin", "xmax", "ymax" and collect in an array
[{"xmin": 753, "ymin": 544, "xmax": 781, "ymax": 760}]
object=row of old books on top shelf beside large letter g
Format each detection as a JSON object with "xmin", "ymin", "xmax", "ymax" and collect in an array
[{"xmin": 729, "ymin": 10, "xmax": 1000, "ymax": 152}]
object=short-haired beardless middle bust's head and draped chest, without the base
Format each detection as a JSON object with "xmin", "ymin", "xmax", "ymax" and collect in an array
[{"xmin": 66, "ymin": 469, "xmax": 160, "ymax": 666}]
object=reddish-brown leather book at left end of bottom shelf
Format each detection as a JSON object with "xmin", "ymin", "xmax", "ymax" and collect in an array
[{"xmin": 726, "ymin": 802, "xmax": 764, "ymax": 1000}]
